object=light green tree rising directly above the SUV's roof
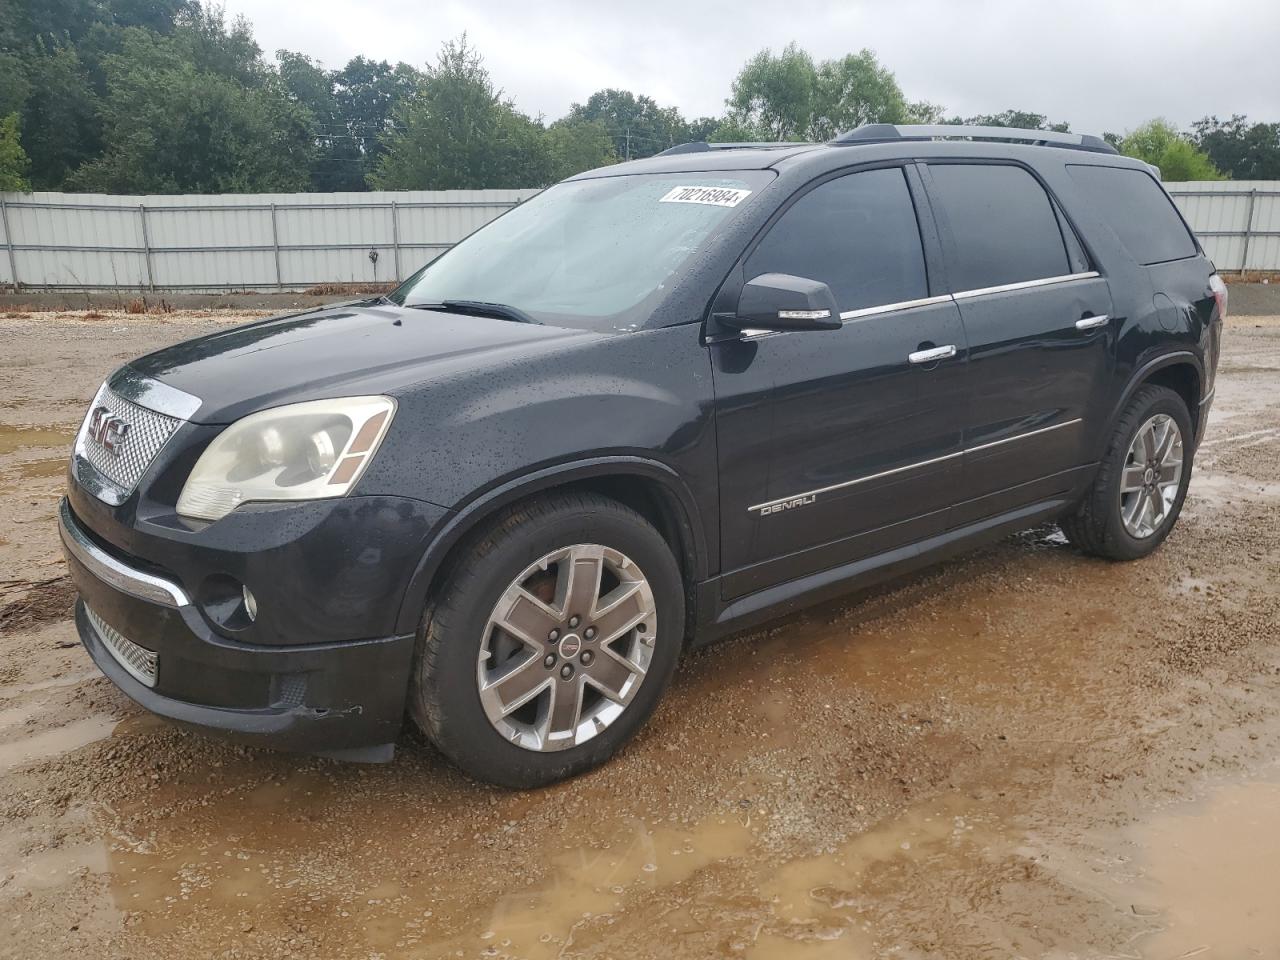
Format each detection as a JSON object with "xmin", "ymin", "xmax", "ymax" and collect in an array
[{"xmin": 714, "ymin": 44, "xmax": 916, "ymax": 141}]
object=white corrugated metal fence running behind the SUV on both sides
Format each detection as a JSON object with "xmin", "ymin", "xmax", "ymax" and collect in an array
[{"xmin": 0, "ymin": 180, "xmax": 1280, "ymax": 291}]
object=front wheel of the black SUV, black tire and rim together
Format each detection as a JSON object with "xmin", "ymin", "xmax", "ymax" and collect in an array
[{"xmin": 410, "ymin": 493, "xmax": 685, "ymax": 788}]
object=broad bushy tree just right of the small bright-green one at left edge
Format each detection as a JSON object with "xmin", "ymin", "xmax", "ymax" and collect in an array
[{"xmin": 68, "ymin": 20, "xmax": 314, "ymax": 193}]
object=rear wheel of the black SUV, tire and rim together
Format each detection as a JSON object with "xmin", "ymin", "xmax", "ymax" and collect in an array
[{"xmin": 1061, "ymin": 385, "xmax": 1192, "ymax": 561}]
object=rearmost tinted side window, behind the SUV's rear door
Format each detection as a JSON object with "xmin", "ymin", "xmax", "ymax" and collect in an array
[{"xmin": 1066, "ymin": 164, "xmax": 1197, "ymax": 264}]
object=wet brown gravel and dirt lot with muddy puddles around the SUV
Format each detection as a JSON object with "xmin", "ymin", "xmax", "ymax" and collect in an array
[{"xmin": 0, "ymin": 314, "xmax": 1280, "ymax": 960}]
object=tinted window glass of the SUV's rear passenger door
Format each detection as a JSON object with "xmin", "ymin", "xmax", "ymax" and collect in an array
[{"xmin": 929, "ymin": 164, "xmax": 1075, "ymax": 292}]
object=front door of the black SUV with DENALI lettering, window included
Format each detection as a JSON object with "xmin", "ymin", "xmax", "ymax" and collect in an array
[{"xmin": 710, "ymin": 166, "xmax": 965, "ymax": 599}]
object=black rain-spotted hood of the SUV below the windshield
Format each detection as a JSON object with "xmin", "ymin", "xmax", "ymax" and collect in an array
[{"xmin": 128, "ymin": 303, "xmax": 602, "ymax": 424}]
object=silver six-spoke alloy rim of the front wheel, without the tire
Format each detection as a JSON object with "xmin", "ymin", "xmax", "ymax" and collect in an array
[{"xmin": 476, "ymin": 544, "xmax": 658, "ymax": 751}]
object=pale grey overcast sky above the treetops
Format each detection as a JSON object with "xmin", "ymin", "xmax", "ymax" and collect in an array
[{"xmin": 227, "ymin": 0, "xmax": 1280, "ymax": 133}]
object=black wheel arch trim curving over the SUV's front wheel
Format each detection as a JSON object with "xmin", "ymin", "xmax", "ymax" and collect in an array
[{"xmin": 397, "ymin": 456, "xmax": 709, "ymax": 632}]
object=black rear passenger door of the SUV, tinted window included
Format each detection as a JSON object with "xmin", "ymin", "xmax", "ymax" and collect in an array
[{"xmin": 924, "ymin": 161, "xmax": 1115, "ymax": 526}]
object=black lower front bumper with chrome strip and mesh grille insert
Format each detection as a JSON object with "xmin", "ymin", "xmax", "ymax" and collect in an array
[{"xmin": 59, "ymin": 500, "xmax": 413, "ymax": 760}]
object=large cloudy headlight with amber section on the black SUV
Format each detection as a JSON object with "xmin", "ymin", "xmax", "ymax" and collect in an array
[{"xmin": 178, "ymin": 397, "xmax": 396, "ymax": 520}]
